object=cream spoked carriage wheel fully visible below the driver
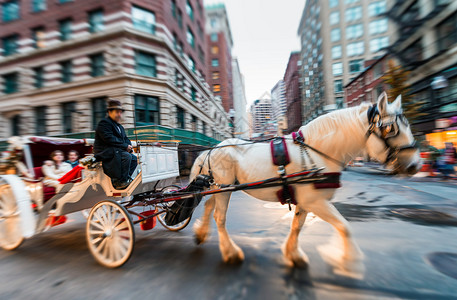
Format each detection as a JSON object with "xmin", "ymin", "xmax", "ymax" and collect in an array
[{"xmin": 86, "ymin": 200, "xmax": 135, "ymax": 268}]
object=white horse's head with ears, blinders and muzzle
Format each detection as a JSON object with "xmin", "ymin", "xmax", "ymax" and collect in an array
[{"xmin": 367, "ymin": 92, "xmax": 421, "ymax": 175}]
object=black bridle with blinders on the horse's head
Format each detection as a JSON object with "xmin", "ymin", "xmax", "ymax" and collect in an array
[{"xmin": 366, "ymin": 104, "xmax": 417, "ymax": 164}]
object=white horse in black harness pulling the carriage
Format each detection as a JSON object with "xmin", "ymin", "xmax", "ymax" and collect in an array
[{"xmin": 190, "ymin": 93, "xmax": 420, "ymax": 273}]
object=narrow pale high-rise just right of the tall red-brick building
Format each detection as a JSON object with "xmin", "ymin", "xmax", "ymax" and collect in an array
[{"xmin": 231, "ymin": 58, "xmax": 249, "ymax": 138}]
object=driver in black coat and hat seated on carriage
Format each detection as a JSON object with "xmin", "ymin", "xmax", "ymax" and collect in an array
[{"xmin": 94, "ymin": 99, "xmax": 138, "ymax": 190}]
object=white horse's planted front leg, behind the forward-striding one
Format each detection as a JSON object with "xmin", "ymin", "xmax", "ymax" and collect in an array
[{"xmin": 282, "ymin": 206, "xmax": 308, "ymax": 267}]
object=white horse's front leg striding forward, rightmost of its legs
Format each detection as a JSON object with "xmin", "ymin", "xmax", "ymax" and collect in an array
[{"xmin": 310, "ymin": 200, "xmax": 363, "ymax": 276}]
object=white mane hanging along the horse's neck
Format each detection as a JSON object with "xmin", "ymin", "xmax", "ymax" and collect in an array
[{"xmin": 300, "ymin": 103, "xmax": 370, "ymax": 156}]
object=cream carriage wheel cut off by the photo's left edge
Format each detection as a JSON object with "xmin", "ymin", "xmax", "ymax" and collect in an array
[{"xmin": 0, "ymin": 182, "xmax": 24, "ymax": 250}]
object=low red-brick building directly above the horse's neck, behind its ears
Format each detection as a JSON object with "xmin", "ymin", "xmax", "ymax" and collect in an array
[{"xmin": 344, "ymin": 54, "xmax": 389, "ymax": 107}]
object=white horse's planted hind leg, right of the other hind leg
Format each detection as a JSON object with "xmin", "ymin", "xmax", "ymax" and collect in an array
[{"xmin": 214, "ymin": 193, "xmax": 244, "ymax": 263}]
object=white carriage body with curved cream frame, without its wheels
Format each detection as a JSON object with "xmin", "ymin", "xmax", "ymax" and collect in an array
[{"xmin": 0, "ymin": 137, "xmax": 179, "ymax": 238}]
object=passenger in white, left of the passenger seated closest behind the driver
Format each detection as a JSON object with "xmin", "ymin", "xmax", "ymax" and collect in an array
[{"xmin": 42, "ymin": 150, "xmax": 72, "ymax": 192}]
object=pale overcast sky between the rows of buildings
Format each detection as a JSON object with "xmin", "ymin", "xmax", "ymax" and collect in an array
[{"xmin": 204, "ymin": 0, "xmax": 306, "ymax": 105}]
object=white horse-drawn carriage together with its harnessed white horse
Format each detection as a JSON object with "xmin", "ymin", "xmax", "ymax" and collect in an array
[{"xmin": 0, "ymin": 93, "xmax": 421, "ymax": 273}]
